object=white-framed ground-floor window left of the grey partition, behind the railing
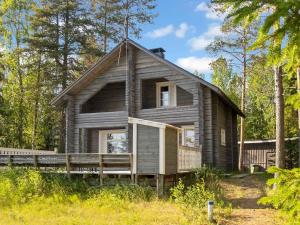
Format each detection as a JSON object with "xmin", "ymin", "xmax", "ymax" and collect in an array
[{"xmin": 99, "ymin": 130, "xmax": 128, "ymax": 153}]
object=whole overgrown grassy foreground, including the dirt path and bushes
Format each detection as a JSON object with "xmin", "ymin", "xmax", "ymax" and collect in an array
[{"xmin": 0, "ymin": 168, "xmax": 300, "ymax": 225}]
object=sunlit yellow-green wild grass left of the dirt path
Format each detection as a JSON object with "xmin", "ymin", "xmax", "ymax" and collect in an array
[{"xmin": 0, "ymin": 169, "xmax": 231, "ymax": 225}]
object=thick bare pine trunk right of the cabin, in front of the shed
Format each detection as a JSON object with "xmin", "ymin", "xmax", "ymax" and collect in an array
[{"xmin": 274, "ymin": 66, "xmax": 285, "ymax": 171}]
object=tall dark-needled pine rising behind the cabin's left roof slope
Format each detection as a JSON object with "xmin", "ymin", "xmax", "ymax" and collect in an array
[{"xmin": 29, "ymin": 0, "xmax": 102, "ymax": 151}]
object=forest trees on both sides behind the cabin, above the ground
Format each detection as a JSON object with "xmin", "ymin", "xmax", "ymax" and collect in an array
[{"xmin": 0, "ymin": 0, "xmax": 299, "ymax": 158}]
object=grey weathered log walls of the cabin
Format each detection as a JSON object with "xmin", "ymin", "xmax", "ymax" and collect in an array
[{"xmin": 63, "ymin": 43, "xmax": 237, "ymax": 169}]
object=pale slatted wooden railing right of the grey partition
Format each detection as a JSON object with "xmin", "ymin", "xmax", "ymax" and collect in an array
[{"xmin": 177, "ymin": 146, "xmax": 202, "ymax": 172}]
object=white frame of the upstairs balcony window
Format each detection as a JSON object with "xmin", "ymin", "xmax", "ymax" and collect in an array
[{"xmin": 156, "ymin": 81, "xmax": 177, "ymax": 108}]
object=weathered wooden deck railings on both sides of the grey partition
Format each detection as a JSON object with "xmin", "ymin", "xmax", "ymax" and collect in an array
[{"xmin": 0, "ymin": 146, "xmax": 202, "ymax": 179}]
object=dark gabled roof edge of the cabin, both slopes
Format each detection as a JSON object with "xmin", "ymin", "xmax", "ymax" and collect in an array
[{"xmin": 51, "ymin": 39, "xmax": 245, "ymax": 117}]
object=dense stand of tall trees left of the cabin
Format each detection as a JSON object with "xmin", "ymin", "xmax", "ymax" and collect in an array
[{"xmin": 0, "ymin": 0, "xmax": 156, "ymax": 150}]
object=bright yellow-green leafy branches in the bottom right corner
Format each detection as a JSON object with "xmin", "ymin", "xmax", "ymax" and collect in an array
[{"xmin": 259, "ymin": 167, "xmax": 300, "ymax": 224}]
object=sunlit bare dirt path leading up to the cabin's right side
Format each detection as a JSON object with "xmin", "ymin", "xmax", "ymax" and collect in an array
[{"xmin": 222, "ymin": 175, "xmax": 282, "ymax": 225}]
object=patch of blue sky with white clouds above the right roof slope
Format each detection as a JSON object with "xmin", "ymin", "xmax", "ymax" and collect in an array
[{"xmin": 130, "ymin": 0, "xmax": 223, "ymax": 77}]
